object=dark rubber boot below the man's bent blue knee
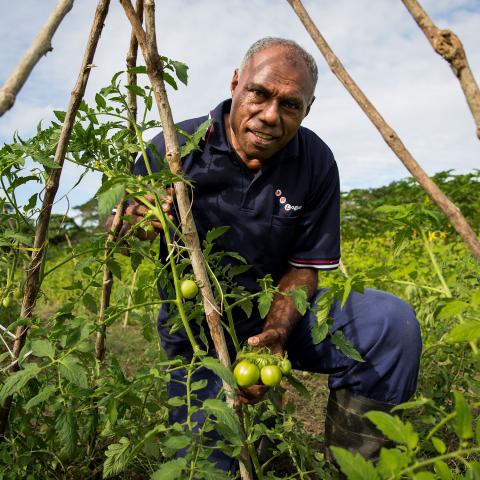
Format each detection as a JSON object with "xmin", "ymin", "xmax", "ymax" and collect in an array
[{"xmin": 325, "ymin": 390, "xmax": 392, "ymax": 463}]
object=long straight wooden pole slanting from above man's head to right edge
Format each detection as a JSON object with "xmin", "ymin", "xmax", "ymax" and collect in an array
[{"xmin": 287, "ymin": 0, "xmax": 480, "ymax": 261}]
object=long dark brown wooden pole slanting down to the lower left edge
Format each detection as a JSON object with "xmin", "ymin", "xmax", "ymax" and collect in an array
[{"xmin": 0, "ymin": 0, "xmax": 110, "ymax": 436}]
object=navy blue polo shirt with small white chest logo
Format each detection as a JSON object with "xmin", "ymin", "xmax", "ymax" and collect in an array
[{"xmin": 134, "ymin": 100, "xmax": 340, "ymax": 291}]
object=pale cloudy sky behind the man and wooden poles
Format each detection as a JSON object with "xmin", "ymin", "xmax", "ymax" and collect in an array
[{"xmin": 0, "ymin": 0, "xmax": 480, "ymax": 213}]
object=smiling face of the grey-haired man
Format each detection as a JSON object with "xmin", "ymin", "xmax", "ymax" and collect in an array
[{"xmin": 227, "ymin": 45, "xmax": 313, "ymax": 170}]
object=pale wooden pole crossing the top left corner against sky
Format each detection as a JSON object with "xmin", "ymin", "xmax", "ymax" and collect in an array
[{"xmin": 0, "ymin": 0, "xmax": 73, "ymax": 117}]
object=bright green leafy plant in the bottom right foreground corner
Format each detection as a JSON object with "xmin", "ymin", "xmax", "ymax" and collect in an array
[{"xmin": 332, "ymin": 392, "xmax": 480, "ymax": 480}]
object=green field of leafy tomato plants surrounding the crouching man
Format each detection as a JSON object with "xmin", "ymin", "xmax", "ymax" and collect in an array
[{"xmin": 0, "ymin": 68, "xmax": 480, "ymax": 480}]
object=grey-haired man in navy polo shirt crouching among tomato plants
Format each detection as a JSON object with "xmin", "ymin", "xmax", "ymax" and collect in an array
[{"xmin": 114, "ymin": 38, "xmax": 421, "ymax": 470}]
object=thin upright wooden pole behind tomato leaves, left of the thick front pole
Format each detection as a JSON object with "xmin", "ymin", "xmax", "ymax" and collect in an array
[{"xmin": 95, "ymin": 0, "xmax": 143, "ymax": 362}]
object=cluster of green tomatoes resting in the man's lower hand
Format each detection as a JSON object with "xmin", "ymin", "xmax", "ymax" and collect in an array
[{"xmin": 233, "ymin": 349, "xmax": 292, "ymax": 387}]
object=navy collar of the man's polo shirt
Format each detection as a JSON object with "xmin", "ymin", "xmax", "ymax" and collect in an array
[{"xmin": 205, "ymin": 98, "xmax": 299, "ymax": 165}]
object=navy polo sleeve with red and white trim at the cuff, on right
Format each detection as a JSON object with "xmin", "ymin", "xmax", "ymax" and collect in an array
[{"xmin": 288, "ymin": 157, "xmax": 340, "ymax": 270}]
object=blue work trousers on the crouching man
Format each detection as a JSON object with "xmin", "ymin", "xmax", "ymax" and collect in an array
[{"xmin": 162, "ymin": 289, "xmax": 422, "ymax": 471}]
